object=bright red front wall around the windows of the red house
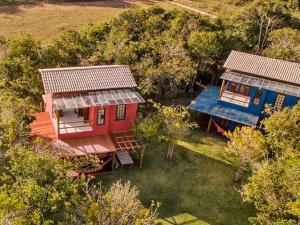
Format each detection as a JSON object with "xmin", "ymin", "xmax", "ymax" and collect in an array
[{"xmin": 58, "ymin": 104, "xmax": 138, "ymax": 139}]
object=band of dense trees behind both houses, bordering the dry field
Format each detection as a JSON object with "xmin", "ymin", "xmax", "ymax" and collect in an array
[{"xmin": 0, "ymin": 4, "xmax": 299, "ymax": 104}]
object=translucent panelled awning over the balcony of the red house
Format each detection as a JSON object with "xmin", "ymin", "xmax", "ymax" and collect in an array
[{"xmin": 53, "ymin": 89, "xmax": 145, "ymax": 110}]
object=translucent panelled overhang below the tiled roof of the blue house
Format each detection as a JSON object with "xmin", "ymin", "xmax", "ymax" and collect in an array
[{"xmin": 220, "ymin": 71, "xmax": 300, "ymax": 97}]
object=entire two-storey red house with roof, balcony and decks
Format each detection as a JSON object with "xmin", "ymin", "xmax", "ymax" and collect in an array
[{"xmin": 31, "ymin": 65, "xmax": 145, "ymax": 173}]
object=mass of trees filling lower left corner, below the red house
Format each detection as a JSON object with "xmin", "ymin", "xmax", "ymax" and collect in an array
[{"xmin": 0, "ymin": 142, "xmax": 157, "ymax": 225}]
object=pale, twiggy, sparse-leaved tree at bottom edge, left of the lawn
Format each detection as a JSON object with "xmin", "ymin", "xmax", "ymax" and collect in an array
[{"xmin": 68, "ymin": 181, "xmax": 158, "ymax": 225}]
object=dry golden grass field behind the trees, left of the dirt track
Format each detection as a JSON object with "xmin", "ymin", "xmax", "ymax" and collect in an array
[{"xmin": 0, "ymin": 0, "xmax": 175, "ymax": 41}]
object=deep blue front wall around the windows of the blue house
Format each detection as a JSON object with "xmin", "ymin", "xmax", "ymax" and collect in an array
[{"xmin": 218, "ymin": 87, "xmax": 298, "ymax": 118}]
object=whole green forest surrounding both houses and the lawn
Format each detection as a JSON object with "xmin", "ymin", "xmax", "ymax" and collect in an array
[{"xmin": 0, "ymin": 0, "xmax": 300, "ymax": 225}]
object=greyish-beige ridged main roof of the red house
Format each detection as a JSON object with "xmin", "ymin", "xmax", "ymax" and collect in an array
[{"xmin": 39, "ymin": 65, "xmax": 137, "ymax": 93}]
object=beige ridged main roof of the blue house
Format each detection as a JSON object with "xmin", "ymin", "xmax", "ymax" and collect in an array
[{"xmin": 224, "ymin": 51, "xmax": 300, "ymax": 85}]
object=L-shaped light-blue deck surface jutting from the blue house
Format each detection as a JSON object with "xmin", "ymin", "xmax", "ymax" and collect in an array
[{"xmin": 189, "ymin": 86, "xmax": 259, "ymax": 126}]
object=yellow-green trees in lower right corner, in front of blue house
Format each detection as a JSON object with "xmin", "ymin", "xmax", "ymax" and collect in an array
[{"xmin": 228, "ymin": 103, "xmax": 300, "ymax": 225}]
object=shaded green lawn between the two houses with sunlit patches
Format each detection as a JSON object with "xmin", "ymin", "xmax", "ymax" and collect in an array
[{"xmin": 97, "ymin": 132, "xmax": 254, "ymax": 225}]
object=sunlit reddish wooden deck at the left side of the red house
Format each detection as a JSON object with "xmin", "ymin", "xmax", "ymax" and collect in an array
[{"xmin": 30, "ymin": 112, "xmax": 57, "ymax": 140}]
